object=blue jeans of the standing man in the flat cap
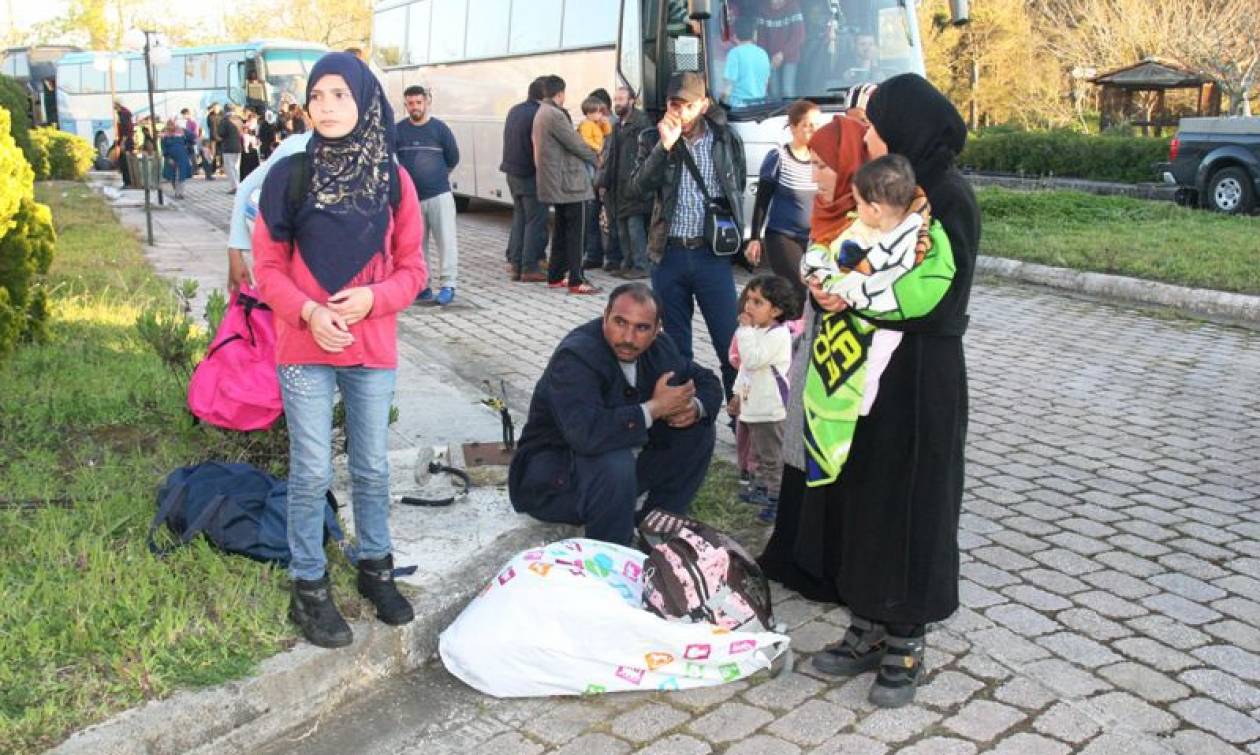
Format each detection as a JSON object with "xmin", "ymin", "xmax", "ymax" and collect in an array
[{"xmin": 651, "ymin": 246, "xmax": 738, "ymax": 398}]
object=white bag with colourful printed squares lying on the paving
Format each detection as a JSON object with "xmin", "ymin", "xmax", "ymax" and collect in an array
[{"xmin": 438, "ymin": 538, "xmax": 789, "ymax": 697}]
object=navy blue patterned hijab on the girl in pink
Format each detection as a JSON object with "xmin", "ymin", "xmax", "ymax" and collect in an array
[{"xmin": 258, "ymin": 53, "xmax": 394, "ymax": 294}]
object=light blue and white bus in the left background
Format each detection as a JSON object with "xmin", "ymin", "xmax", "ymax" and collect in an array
[{"xmin": 57, "ymin": 40, "xmax": 328, "ymax": 154}]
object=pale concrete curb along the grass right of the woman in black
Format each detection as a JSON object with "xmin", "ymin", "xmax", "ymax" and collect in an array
[{"xmin": 975, "ymin": 256, "xmax": 1260, "ymax": 329}]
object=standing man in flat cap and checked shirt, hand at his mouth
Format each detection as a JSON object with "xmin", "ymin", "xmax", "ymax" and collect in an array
[{"xmin": 634, "ymin": 71, "xmax": 747, "ymax": 396}]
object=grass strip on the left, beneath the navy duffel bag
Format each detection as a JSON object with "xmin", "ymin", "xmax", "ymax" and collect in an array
[{"xmin": 0, "ymin": 183, "xmax": 363, "ymax": 752}]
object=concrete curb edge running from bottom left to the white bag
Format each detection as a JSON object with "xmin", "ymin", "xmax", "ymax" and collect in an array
[{"xmin": 50, "ymin": 523, "xmax": 572, "ymax": 755}]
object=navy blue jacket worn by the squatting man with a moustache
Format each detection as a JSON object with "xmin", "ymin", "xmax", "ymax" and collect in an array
[{"xmin": 508, "ymin": 319, "xmax": 723, "ymax": 503}]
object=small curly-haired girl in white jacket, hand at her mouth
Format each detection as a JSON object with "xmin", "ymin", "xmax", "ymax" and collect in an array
[{"xmin": 735, "ymin": 275, "xmax": 800, "ymax": 524}]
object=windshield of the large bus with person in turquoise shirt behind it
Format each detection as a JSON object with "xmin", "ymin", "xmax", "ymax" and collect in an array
[{"xmin": 706, "ymin": 0, "xmax": 924, "ymax": 115}]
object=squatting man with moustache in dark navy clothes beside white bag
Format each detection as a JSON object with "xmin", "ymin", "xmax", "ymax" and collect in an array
[{"xmin": 508, "ymin": 282, "xmax": 722, "ymax": 545}]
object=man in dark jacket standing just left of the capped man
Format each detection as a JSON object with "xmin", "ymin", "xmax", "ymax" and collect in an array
[{"xmin": 597, "ymin": 87, "xmax": 651, "ymax": 280}]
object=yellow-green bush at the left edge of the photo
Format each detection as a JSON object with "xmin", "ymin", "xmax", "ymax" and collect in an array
[{"xmin": 0, "ymin": 107, "xmax": 57, "ymax": 357}]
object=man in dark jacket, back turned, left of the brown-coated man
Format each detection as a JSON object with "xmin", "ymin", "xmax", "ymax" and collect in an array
[{"xmin": 499, "ymin": 76, "xmax": 547, "ymax": 282}]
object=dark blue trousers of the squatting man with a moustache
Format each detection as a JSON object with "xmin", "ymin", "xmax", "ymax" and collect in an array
[{"xmin": 529, "ymin": 422, "xmax": 717, "ymax": 546}]
